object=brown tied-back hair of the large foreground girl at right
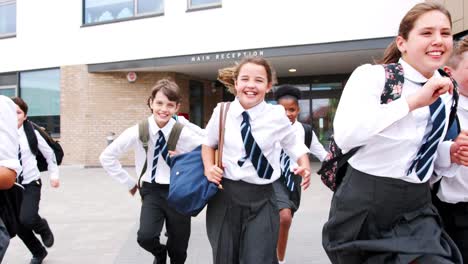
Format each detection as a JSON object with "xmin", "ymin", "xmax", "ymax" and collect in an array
[{"xmin": 377, "ymin": 2, "xmax": 452, "ymax": 64}]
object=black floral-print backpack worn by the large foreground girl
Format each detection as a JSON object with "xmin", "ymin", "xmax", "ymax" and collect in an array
[{"xmin": 317, "ymin": 63, "xmax": 459, "ymax": 191}]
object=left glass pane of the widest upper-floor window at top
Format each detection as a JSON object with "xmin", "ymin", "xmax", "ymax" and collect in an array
[{"xmin": 85, "ymin": 0, "xmax": 134, "ymax": 23}]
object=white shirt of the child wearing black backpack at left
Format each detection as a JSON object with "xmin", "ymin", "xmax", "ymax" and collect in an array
[{"xmin": 18, "ymin": 126, "xmax": 59, "ymax": 184}]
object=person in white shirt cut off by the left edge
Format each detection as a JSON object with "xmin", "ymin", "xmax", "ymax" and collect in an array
[{"xmin": 0, "ymin": 95, "xmax": 22, "ymax": 263}]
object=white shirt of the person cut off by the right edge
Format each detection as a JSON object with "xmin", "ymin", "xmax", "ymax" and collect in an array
[{"xmin": 436, "ymin": 94, "xmax": 468, "ymax": 204}]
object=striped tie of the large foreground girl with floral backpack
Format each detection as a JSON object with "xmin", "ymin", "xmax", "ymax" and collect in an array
[{"xmin": 408, "ymin": 97, "xmax": 446, "ymax": 181}]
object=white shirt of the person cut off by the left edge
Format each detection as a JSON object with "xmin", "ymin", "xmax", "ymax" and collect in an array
[{"xmin": 0, "ymin": 95, "xmax": 22, "ymax": 176}]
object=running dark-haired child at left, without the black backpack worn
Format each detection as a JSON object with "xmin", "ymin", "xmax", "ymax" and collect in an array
[{"xmin": 12, "ymin": 97, "xmax": 60, "ymax": 264}]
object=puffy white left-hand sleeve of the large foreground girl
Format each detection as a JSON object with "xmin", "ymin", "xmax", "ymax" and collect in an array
[{"xmin": 333, "ymin": 64, "xmax": 409, "ymax": 152}]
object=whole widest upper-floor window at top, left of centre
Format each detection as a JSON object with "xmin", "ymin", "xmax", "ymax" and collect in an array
[{"xmin": 84, "ymin": 0, "xmax": 164, "ymax": 24}]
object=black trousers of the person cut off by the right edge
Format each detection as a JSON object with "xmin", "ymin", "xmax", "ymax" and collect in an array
[{"xmin": 433, "ymin": 195, "xmax": 468, "ymax": 263}]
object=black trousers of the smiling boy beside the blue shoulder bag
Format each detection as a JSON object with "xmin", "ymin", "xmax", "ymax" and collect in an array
[{"xmin": 137, "ymin": 182, "xmax": 191, "ymax": 264}]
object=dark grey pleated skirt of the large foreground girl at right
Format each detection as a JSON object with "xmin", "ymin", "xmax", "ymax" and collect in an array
[{"xmin": 322, "ymin": 166, "xmax": 462, "ymax": 264}]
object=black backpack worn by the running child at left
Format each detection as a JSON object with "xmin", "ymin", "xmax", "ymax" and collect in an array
[{"xmin": 23, "ymin": 120, "xmax": 64, "ymax": 171}]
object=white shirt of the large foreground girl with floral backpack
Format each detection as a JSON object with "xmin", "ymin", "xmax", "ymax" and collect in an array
[{"xmin": 333, "ymin": 59, "xmax": 452, "ymax": 183}]
